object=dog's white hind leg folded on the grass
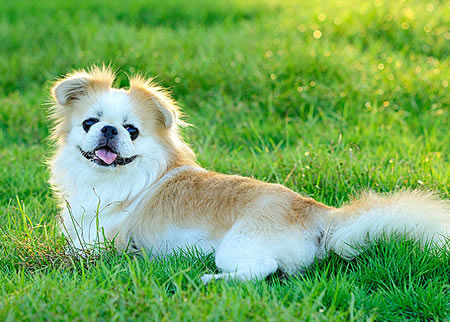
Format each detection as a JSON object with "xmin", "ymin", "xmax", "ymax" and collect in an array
[{"xmin": 202, "ymin": 214, "xmax": 320, "ymax": 283}]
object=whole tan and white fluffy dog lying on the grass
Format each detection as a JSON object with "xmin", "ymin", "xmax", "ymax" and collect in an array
[{"xmin": 49, "ymin": 66, "xmax": 450, "ymax": 283}]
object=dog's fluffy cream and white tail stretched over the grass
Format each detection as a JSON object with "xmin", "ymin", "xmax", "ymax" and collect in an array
[{"xmin": 325, "ymin": 190, "xmax": 450, "ymax": 259}]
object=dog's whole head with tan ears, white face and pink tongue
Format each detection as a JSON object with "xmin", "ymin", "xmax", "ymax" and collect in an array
[{"xmin": 51, "ymin": 67, "xmax": 194, "ymax": 180}]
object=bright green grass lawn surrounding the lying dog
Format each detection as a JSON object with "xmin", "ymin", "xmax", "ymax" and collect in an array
[{"xmin": 0, "ymin": 0, "xmax": 450, "ymax": 321}]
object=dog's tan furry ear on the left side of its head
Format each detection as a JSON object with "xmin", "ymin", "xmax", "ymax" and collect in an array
[{"xmin": 52, "ymin": 66, "xmax": 115, "ymax": 105}]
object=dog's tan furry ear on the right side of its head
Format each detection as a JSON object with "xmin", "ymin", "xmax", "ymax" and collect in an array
[{"xmin": 130, "ymin": 76, "xmax": 178, "ymax": 129}]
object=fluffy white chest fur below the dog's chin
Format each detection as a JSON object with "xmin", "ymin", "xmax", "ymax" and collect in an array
[{"xmin": 52, "ymin": 150, "xmax": 155, "ymax": 248}]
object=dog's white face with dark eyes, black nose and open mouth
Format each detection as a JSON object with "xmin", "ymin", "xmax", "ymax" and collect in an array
[{"xmin": 67, "ymin": 89, "xmax": 142, "ymax": 167}]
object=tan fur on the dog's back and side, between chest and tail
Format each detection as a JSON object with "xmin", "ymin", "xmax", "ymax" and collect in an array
[{"xmin": 125, "ymin": 170, "xmax": 328, "ymax": 239}]
